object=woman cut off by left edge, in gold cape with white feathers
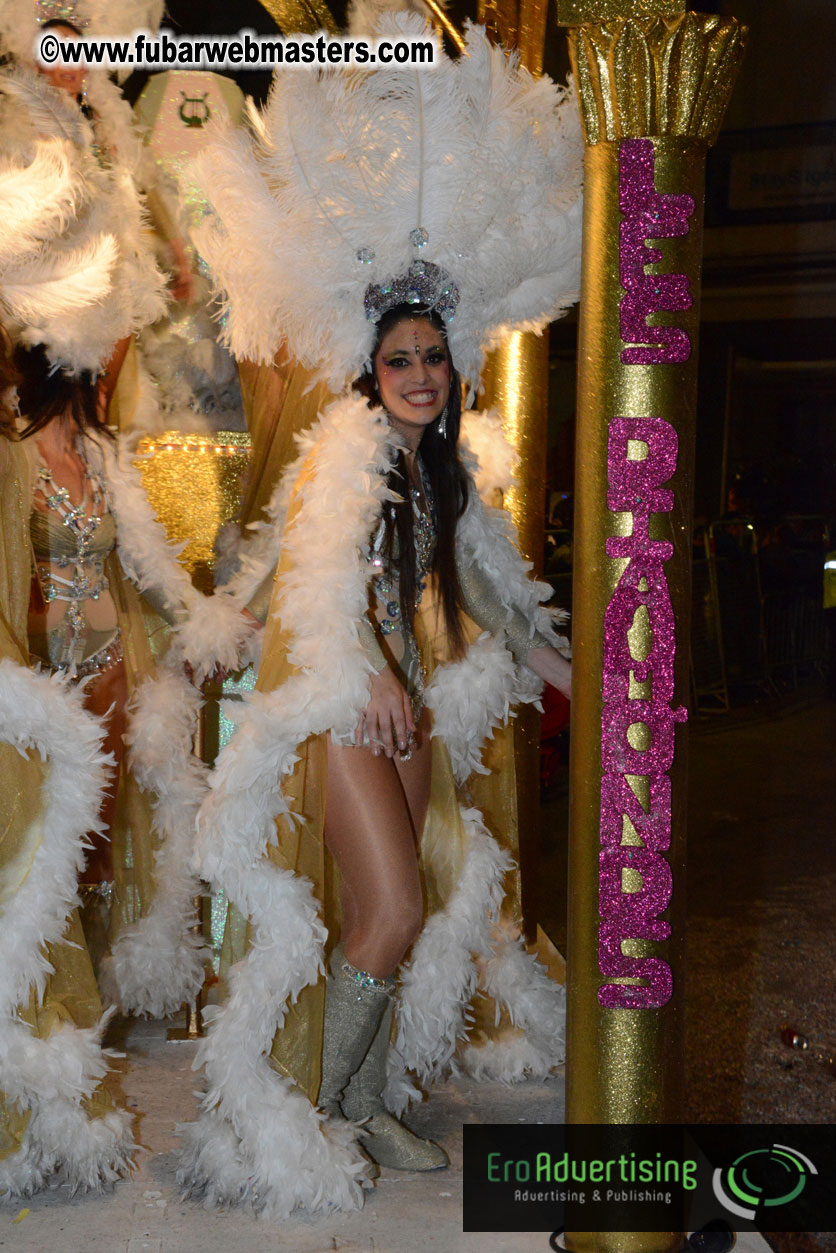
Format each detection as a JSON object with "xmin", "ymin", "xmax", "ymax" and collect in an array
[{"xmin": 0, "ymin": 142, "xmax": 134, "ymax": 1198}]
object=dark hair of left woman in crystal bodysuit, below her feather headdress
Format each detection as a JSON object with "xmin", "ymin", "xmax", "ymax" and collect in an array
[{"xmin": 14, "ymin": 343, "xmax": 114, "ymax": 440}]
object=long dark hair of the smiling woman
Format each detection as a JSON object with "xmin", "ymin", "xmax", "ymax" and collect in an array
[{"xmin": 353, "ymin": 304, "xmax": 468, "ymax": 657}]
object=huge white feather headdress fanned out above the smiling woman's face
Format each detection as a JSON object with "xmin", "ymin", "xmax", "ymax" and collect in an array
[{"xmin": 192, "ymin": 13, "xmax": 583, "ymax": 388}]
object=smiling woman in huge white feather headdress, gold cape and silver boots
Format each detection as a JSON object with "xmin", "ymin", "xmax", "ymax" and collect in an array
[{"xmin": 180, "ymin": 15, "xmax": 582, "ymax": 1217}]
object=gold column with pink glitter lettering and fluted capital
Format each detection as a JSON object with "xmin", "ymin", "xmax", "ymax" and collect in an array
[{"xmin": 558, "ymin": 0, "xmax": 745, "ymax": 1253}]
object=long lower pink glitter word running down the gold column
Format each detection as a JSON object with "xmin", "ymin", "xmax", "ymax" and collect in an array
[{"xmin": 598, "ymin": 417, "xmax": 687, "ymax": 1009}]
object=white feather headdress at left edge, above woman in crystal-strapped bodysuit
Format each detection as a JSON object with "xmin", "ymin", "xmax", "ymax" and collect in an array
[{"xmin": 0, "ymin": 70, "xmax": 165, "ymax": 372}]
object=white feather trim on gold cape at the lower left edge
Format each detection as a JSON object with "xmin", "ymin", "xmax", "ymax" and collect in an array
[{"xmin": 0, "ymin": 660, "xmax": 135, "ymax": 1197}]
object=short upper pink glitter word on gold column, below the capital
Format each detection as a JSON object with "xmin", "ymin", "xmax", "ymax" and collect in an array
[{"xmin": 619, "ymin": 139, "xmax": 694, "ymax": 366}]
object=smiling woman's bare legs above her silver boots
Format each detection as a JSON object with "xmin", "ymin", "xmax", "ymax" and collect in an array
[{"xmin": 325, "ymin": 706, "xmax": 431, "ymax": 979}]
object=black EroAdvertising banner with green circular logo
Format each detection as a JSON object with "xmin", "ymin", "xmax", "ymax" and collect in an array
[{"xmin": 464, "ymin": 1124, "xmax": 836, "ymax": 1233}]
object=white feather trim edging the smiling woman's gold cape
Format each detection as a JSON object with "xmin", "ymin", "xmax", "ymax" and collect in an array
[{"xmin": 178, "ymin": 397, "xmax": 560, "ymax": 1218}]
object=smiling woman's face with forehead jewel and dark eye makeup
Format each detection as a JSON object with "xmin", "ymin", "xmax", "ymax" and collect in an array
[{"xmin": 374, "ymin": 317, "xmax": 450, "ymax": 449}]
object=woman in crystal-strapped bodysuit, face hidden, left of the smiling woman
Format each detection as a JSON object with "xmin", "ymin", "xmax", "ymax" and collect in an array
[{"xmin": 0, "ymin": 41, "xmax": 255, "ymax": 1016}]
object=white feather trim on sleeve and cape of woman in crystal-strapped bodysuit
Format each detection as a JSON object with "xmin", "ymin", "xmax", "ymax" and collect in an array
[{"xmin": 79, "ymin": 440, "xmax": 245, "ymax": 1017}]
